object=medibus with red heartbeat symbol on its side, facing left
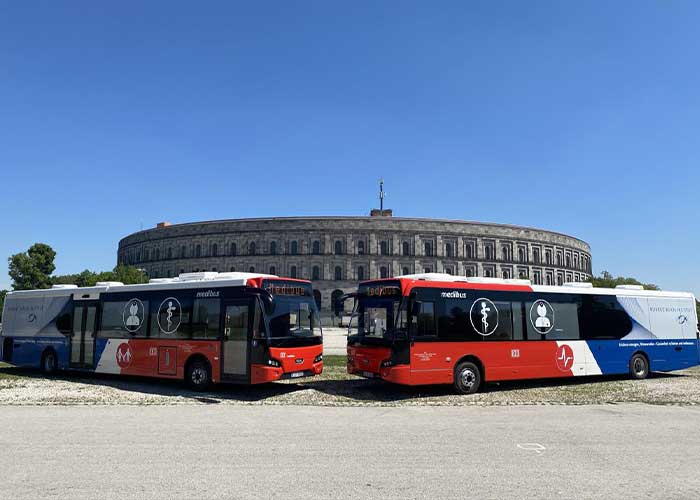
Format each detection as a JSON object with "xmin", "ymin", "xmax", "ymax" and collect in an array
[{"xmin": 344, "ymin": 273, "xmax": 700, "ymax": 394}]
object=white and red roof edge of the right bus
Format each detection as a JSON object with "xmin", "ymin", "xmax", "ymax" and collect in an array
[{"xmin": 361, "ymin": 273, "xmax": 695, "ymax": 299}]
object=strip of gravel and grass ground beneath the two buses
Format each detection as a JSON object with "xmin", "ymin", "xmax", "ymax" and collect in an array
[{"xmin": 0, "ymin": 357, "xmax": 700, "ymax": 406}]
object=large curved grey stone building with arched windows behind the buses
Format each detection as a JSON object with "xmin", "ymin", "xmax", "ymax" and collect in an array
[{"xmin": 118, "ymin": 210, "xmax": 591, "ymax": 316}]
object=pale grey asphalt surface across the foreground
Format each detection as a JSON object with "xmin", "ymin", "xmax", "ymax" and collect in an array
[{"xmin": 0, "ymin": 404, "xmax": 700, "ymax": 500}]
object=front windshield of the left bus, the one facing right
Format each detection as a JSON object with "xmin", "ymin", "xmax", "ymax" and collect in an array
[{"xmin": 269, "ymin": 296, "xmax": 321, "ymax": 338}]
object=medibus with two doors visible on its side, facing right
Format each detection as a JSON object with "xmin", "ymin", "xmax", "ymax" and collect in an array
[{"xmin": 1, "ymin": 272, "xmax": 323, "ymax": 390}]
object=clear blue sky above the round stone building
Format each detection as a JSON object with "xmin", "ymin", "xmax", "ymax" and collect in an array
[{"xmin": 0, "ymin": 1, "xmax": 700, "ymax": 295}]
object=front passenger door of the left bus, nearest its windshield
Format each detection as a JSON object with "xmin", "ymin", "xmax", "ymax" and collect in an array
[{"xmin": 221, "ymin": 299, "xmax": 253, "ymax": 379}]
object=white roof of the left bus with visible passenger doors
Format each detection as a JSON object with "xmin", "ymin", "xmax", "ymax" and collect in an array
[{"xmin": 8, "ymin": 272, "xmax": 310, "ymax": 298}]
